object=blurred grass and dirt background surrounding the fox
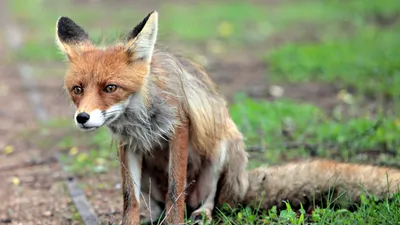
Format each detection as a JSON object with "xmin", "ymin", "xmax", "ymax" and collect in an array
[{"xmin": 0, "ymin": 0, "xmax": 400, "ymax": 224}]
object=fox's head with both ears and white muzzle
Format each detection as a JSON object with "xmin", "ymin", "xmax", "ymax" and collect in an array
[{"xmin": 56, "ymin": 11, "xmax": 158, "ymax": 131}]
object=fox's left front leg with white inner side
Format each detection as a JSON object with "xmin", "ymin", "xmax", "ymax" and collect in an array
[{"xmin": 119, "ymin": 145, "xmax": 142, "ymax": 225}]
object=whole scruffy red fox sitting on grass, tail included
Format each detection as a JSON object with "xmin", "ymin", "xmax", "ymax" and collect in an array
[{"xmin": 56, "ymin": 11, "xmax": 400, "ymax": 224}]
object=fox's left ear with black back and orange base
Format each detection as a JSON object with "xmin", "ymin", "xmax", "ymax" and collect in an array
[{"xmin": 56, "ymin": 16, "xmax": 91, "ymax": 59}]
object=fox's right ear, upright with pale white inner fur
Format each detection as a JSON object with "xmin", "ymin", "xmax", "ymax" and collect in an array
[{"xmin": 126, "ymin": 11, "xmax": 158, "ymax": 63}]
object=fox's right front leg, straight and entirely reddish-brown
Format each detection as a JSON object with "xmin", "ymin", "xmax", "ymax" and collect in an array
[{"xmin": 166, "ymin": 124, "xmax": 189, "ymax": 224}]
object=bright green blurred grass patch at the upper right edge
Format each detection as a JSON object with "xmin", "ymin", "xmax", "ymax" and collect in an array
[{"xmin": 264, "ymin": 0, "xmax": 400, "ymax": 109}]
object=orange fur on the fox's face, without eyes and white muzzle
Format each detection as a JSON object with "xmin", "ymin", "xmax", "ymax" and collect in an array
[{"xmin": 64, "ymin": 47, "xmax": 149, "ymax": 112}]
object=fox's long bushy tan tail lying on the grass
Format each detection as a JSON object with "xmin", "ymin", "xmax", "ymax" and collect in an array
[{"xmin": 243, "ymin": 160, "xmax": 400, "ymax": 209}]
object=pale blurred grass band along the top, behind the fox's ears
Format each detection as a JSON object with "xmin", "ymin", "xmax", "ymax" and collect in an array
[{"xmin": 8, "ymin": 0, "xmax": 397, "ymax": 62}]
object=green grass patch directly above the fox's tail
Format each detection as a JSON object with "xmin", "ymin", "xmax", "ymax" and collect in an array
[{"xmin": 230, "ymin": 95, "xmax": 400, "ymax": 168}]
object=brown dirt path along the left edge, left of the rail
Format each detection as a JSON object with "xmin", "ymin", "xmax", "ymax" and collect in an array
[{"xmin": 0, "ymin": 3, "xmax": 87, "ymax": 225}]
